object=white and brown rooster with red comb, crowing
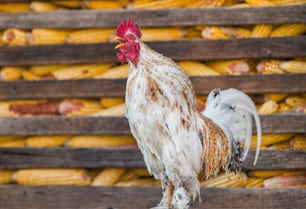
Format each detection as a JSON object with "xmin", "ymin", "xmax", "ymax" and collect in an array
[{"xmin": 114, "ymin": 19, "xmax": 261, "ymax": 209}]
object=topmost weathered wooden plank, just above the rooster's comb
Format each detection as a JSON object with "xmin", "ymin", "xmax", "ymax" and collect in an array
[{"xmin": 0, "ymin": 5, "xmax": 306, "ymax": 29}]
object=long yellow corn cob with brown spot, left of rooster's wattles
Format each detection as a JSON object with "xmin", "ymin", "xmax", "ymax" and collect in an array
[{"xmin": 52, "ymin": 63, "xmax": 112, "ymax": 80}]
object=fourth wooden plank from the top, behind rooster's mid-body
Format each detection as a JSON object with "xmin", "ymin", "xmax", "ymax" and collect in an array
[{"xmin": 0, "ymin": 113, "xmax": 306, "ymax": 136}]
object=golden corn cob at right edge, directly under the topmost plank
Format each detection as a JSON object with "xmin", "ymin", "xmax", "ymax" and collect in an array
[{"xmin": 270, "ymin": 24, "xmax": 306, "ymax": 37}]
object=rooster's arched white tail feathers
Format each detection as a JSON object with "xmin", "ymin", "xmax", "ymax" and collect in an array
[{"xmin": 202, "ymin": 88, "xmax": 261, "ymax": 165}]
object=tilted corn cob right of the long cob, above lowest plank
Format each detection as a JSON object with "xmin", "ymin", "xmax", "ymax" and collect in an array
[{"xmin": 91, "ymin": 168, "xmax": 126, "ymax": 186}]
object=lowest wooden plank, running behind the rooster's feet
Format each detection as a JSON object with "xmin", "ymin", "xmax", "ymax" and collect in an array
[{"xmin": 0, "ymin": 185, "xmax": 306, "ymax": 209}]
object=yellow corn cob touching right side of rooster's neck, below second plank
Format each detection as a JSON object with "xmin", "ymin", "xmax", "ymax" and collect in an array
[{"xmin": 179, "ymin": 61, "xmax": 220, "ymax": 76}]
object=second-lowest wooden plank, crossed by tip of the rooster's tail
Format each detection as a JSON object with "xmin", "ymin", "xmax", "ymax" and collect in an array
[{"xmin": 0, "ymin": 147, "xmax": 306, "ymax": 170}]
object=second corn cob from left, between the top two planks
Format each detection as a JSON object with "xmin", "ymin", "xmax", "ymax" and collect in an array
[{"xmin": 28, "ymin": 28, "xmax": 70, "ymax": 45}]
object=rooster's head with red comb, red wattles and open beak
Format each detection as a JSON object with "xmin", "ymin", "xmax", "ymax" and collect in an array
[{"xmin": 114, "ymin": 19, "xmax": 141, "ymax": 66}]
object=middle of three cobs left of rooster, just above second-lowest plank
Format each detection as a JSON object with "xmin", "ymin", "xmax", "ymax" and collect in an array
[{"xmin": 26, "ymin": 136, "xmax": 68, "ymax": 147}]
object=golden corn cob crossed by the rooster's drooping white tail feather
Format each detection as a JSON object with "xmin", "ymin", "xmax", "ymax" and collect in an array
[{"xmin": 250, "ymin": 134, "xmax": 294, "ymax": 149}]
